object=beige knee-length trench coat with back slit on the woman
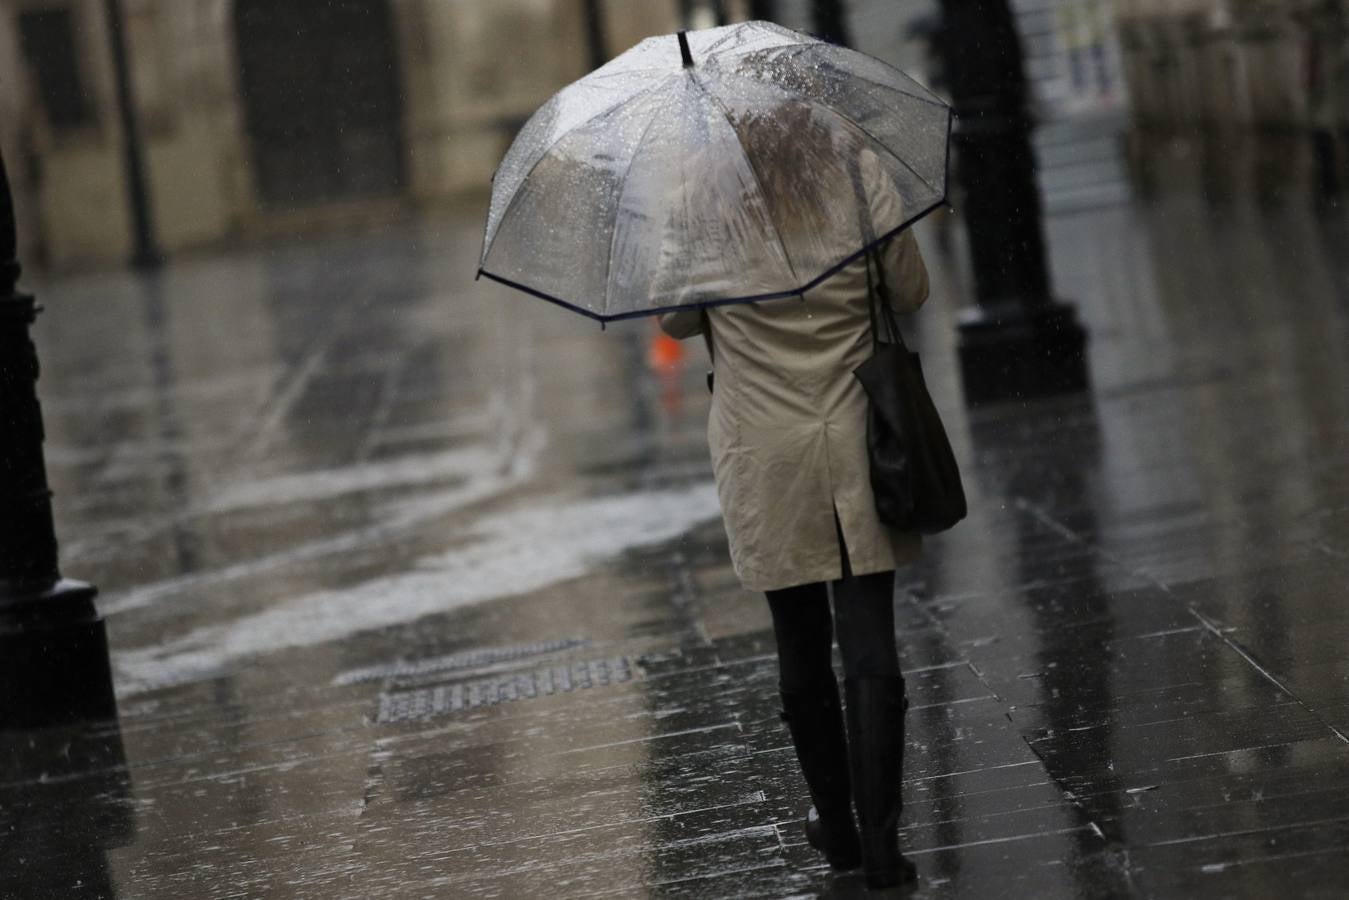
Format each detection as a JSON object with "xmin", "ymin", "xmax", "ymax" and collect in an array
[{"xmin": 661, "ymin": 155, "xmax": 928, "ymax": 591}]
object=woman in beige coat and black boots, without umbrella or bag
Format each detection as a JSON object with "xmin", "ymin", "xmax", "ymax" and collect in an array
[{"xmin": 661, "ymin": 144, "xmax": 928, "ymax": 888}]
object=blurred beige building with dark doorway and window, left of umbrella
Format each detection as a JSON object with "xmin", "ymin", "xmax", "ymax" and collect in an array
[{"xmin": 0, "ymin": 0, "xmax": 712, "ymax": 269}]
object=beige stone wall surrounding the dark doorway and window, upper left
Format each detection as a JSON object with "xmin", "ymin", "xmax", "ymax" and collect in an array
[{"xmin": 0, "ymin": 0, "xmax": 679, "ymax": 269}]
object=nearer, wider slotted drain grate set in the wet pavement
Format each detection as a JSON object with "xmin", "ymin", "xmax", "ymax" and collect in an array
[{"xmin": 375, "ymin": 656, "xmax": 634, "ymax": 725}]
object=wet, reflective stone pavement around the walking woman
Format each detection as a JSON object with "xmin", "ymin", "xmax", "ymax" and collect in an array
[{"xmin": 0, "ymin": 135, "xmax": 1349, "ymax": 897}]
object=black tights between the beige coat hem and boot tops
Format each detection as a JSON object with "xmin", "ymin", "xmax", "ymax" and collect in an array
[{"xmin": 768, "ymin": 520, "xmax": 900, "ymax": 692}]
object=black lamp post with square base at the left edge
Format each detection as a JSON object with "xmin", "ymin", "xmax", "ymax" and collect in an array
[{"xmin": 0, "ymin": 146, "xmax": 116, "ymax": 730}]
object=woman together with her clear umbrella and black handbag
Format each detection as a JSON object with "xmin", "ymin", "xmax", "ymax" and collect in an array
[{"xmin": 478, "ymin": 22, "xmax": 963, "ymax": 887}]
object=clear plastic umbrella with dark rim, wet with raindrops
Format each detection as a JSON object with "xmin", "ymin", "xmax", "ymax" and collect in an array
[{"xmin": 479, "ymin": 22, "xmax": 951, "ymax": 321}]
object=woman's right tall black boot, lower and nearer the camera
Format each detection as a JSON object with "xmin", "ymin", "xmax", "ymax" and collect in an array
[{"xmin": 843, "ymin": 675, "xmax": 917, "ymax": 888}]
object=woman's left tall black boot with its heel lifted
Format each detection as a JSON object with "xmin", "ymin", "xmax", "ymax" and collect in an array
[{"xmin": 780, "ymin": 683, "xmax": 862, "ymax": 870}]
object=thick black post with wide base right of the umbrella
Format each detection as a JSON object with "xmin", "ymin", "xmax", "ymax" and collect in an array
[{"xmin": 942, "ymin": 0, "xmax": 1087, "ymax": 402}]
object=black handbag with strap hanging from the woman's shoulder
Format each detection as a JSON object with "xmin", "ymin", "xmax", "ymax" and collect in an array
[{"xmin": 853, "ymin": 251, "xmax": 967, "ymax": 534}]
